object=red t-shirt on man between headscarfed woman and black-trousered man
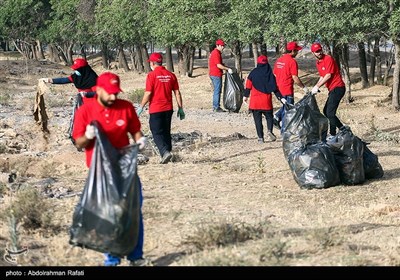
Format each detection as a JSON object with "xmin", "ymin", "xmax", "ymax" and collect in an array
[{"xmin": 274, "ymin": 54, "xmax": 299, "ymax": 96}]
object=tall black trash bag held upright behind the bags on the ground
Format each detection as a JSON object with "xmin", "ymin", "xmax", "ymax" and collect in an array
[{"xmin": 282, "ymin": 94, "xmax": 328, "ymax": 158}]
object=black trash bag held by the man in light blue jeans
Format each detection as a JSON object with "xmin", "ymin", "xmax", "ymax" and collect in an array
[{"xmin": 222, "ymin": 72, "xmax": 244, "ymax": 113}]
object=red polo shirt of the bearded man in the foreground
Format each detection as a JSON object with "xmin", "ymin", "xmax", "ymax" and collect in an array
[{"xmin": 72, "ymin": 95, "xmax": 141, "ymax": 167}]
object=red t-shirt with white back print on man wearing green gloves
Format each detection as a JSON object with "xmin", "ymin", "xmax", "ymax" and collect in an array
[{"xmin": 146, "ymin": 66, "xmax": 179, "ymax": 114}]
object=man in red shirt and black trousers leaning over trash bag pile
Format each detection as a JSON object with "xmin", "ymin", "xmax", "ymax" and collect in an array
[{"xmin": 311, "ymin": 43, "xmax": 346, "ymax": 136}]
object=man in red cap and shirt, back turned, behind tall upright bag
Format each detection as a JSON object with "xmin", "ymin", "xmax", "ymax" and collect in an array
[{"xmin": 274, "ymin": 42, "xmax": 308, "ymax": 132}]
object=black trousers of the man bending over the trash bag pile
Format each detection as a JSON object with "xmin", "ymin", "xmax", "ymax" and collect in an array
[{"xmin": 323, "ymin": 87, "xmax": 346, "ymax": 135}]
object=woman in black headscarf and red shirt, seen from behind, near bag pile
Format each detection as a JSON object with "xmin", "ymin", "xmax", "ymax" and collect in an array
[{"xmin": 243, "ymin": 55, "xmax": 285, "ymax": 143}]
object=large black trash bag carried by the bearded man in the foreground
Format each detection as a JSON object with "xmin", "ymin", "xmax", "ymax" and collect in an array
[{"xmin": 69, "ymin": 121, "xmax": 140, "ymax": 257}]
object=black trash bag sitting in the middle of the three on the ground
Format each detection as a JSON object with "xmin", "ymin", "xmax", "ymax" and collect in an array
[{"xmin": 326, "ymin": 127, "xmax": 365, "ymax": 185}]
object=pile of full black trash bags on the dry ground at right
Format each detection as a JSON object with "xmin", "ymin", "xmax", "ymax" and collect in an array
[{"xmin": 282, "ymin": 94, "xmax": 383, "ymax": 189}]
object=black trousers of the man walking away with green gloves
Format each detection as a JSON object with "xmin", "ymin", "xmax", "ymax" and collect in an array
[{"xmin": 149, "ymin": 110, "xmax": 173, "ymax": 157}]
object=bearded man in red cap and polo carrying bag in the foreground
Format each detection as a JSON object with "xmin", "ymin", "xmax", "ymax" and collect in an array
[{"xmin": 73, "ymin": 72, "xmax": 147, "ymax": 266}]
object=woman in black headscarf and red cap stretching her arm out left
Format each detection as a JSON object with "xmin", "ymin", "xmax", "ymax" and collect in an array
[{"xmin": 39, "ymin": 58, "xmax": 97, "ymax": 144}]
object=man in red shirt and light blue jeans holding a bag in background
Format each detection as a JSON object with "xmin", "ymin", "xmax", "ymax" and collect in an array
[{"xmin": 208, "ymin": 39, "xmax": 232, "ymax": 112}]
